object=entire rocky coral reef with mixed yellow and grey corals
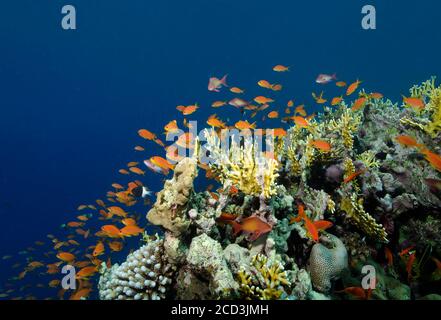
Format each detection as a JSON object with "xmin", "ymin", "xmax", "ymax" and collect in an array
[{"xmin": 100, "ymin": 79, "xmax": 441, "ymax": 300}]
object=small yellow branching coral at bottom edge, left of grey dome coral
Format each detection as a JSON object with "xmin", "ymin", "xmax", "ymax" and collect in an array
[{"xmin": 237, "ymin": 254, "xmax": 290, "ymax": 300}]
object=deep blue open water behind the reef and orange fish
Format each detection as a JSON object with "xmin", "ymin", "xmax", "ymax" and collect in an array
[{"xmin": 0, "ymin": 0, "xmax": 441, "ymax": 298}]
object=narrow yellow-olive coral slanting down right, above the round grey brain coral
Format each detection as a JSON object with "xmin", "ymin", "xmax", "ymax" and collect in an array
[{"xmin": 340, "ymin": 194, "xmax": 388, "ymax": 243}]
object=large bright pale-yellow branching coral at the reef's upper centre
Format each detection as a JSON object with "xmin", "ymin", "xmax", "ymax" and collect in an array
[{"xmin": 205, "ymin": 130, "xmax": 279, "ymax": 198}]
